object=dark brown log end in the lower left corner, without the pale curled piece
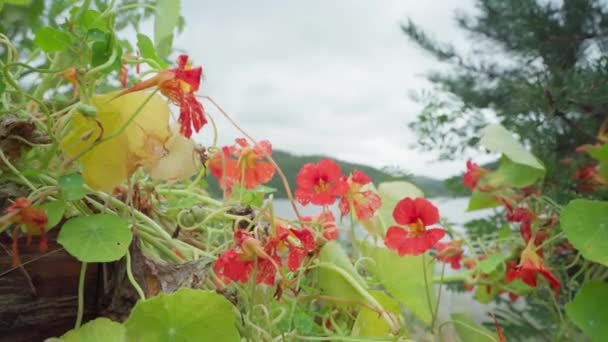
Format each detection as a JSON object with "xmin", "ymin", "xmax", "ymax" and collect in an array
[{"xmin": 0, "ymin": 229, "xmax": 99, "ymax": 342}]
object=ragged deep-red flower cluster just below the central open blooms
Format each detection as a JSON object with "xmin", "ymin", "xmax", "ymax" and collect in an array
[{"xmin": 213, "ymin": 226, "xmax": 315, "ymax": 286}]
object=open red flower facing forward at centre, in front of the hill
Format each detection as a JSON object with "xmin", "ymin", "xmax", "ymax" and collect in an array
[{"xmin": 295, "ymin": 159, "xmax": 348, "ymax": 205}]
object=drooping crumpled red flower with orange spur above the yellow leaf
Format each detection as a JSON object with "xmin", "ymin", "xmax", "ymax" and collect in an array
[{"xmin": 119, "ymin": 55, "xmax": 207, "ymax": 138}]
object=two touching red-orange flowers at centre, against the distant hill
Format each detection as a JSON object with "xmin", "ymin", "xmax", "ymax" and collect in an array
[{"xmin": 295, "ymin": 159, "xmax": 382, "ymax": 221}]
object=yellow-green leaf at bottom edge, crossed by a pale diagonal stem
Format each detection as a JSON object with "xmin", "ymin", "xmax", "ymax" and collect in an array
[{"xmin": 352, "ymin": 291, "xmax": 407, "ymax": 337}]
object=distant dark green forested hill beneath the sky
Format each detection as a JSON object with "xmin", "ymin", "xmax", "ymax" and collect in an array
[{"xmin": 207, "ymin": 150, "xmax": 450, "ymax": 198}]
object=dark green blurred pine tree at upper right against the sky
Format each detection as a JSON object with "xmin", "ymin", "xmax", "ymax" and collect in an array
[{"xmin": 402, "ymin": 0, "xmax": 608, "ymax": 202}]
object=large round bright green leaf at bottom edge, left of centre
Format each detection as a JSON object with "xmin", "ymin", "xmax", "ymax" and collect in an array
[{"xmin": 125, "ymin": 288, "xmax": 240, "ymax": 342}]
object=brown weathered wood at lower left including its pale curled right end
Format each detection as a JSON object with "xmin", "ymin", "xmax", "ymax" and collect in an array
[{"xmin": 0, "ymin": 228, "xmax": 211, "ymax": 342}]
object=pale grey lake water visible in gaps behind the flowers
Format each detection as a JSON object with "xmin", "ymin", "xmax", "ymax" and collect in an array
[{"xmin": 274, "ymin": 197, "xmax": 494, "ymax": 323}]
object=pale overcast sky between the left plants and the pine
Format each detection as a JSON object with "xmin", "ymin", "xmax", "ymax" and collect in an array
[{"xmin": 175, "ymin": 0, "xmax": 480, "ymax": 178}]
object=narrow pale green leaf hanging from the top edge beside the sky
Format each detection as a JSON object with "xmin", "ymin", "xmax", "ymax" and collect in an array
[{"xmin": 154, "ymin": 0, "xmax": 180, "ymax": 59}]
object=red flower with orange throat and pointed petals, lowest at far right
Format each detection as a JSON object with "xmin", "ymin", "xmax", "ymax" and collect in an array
[{"xmin": 506, "ymin": 240, "xmax": 561, "ymax": 296}]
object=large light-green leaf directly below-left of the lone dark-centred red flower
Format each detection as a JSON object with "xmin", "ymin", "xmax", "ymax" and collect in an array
[{"xmin": 361, "ymin": 243, "xmax": 435, "ymax": 324}]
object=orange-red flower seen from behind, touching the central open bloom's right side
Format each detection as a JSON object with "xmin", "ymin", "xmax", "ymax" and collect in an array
[{"xmin": 339, "ymin": 170, "xmax": 382, "ymax": 221}]
